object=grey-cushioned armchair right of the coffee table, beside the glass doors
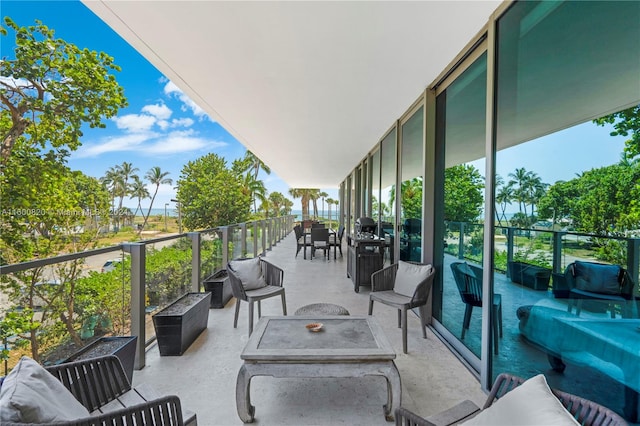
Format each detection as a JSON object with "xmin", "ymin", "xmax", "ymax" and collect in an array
[{"xmin": 369, "ymin": 261, "xmax": 435, "ymax": 354}]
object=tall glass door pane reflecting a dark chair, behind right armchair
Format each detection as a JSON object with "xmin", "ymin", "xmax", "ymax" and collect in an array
[{"xmin": 434, "ymin": 53, "xmax": 487, "ymax": 365}]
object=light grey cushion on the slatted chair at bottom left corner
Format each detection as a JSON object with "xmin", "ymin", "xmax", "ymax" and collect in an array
[{"xmin": 0, "ymin": 356, "xmax": 89, "ymax": 423}]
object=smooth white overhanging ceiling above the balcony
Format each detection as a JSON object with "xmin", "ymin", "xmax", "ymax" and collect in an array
[{"xmin": 83, "ymin": 0, "xmax": 500, "ymax": 188}]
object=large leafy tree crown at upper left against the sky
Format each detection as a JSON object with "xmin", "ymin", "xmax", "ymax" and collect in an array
[{"xmin": 0, "ymin": 17, "xmax": 127, "ymax": 165}]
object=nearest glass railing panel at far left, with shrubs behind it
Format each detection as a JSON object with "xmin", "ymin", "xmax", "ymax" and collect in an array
[{"xmin": 0, "ymin": 249, "xmax": 130, "ymax": 375}]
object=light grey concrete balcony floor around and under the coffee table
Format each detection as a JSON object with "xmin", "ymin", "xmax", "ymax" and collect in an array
[{"xmin": 133, "ymin": 233, "xmax": 486, "ymax": 426}]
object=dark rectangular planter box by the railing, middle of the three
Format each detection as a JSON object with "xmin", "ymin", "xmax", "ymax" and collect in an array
[{"xmin": 153, "ymin": 292, "xmax": 211, "ymax": 356}]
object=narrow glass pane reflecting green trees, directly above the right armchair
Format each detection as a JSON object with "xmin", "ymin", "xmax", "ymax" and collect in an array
[{"xmin": 400, "ymin": 107, "xmax": 424, "ymax": 262}]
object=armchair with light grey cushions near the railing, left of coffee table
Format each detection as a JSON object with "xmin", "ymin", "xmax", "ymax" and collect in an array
[{"xmin": 227, "ymin": 257, "xmax": 287, "ymax": 336}]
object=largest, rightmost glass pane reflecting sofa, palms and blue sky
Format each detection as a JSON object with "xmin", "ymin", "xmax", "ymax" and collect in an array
[{"xmin": 492, "ymin": 1, "xmax": 640, "ymax": 422}]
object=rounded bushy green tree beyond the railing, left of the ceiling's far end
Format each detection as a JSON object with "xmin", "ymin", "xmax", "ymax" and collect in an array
[{"xmin": 177, "ymin": 154, "xmax": 251, "ymax": 229}]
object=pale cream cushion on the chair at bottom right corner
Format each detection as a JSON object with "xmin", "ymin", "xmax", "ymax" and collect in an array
[{"xmin": 460, "ymin": 374, "xmax": 580, "ymax": 426}]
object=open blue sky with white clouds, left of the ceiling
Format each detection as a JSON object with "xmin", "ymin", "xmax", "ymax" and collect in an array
[{"xmin": 0, "ymin": 0, "xmax": 337, "ymax": 210}]
